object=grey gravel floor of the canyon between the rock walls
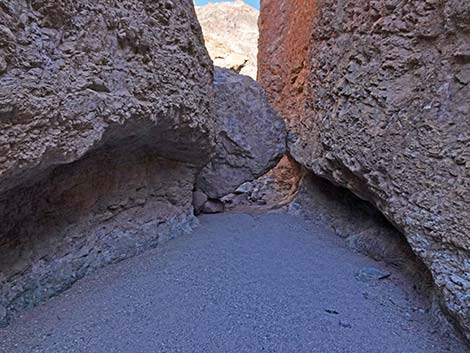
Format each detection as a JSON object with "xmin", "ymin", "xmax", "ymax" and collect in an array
[{"xmin": 0, "ymin": 212, "xmax": 468, "ymax": 353}]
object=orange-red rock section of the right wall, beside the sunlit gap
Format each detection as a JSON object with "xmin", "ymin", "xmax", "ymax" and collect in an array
[{"xmin": 258, "ymin": 0, "xmax": 317, "ymax": 124}]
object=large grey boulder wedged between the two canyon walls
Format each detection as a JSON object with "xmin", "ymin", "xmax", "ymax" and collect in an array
[{"xmin": 197, "ymin": 67, "xmax": 286, "ymax": 199}]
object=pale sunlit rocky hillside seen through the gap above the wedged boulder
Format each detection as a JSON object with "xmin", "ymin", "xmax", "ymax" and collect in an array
[{"xmin": 196, "ymin": 0, "xmax": 259, "ymax": 80}]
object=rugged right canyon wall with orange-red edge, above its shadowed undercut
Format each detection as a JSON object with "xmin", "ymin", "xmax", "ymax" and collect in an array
[{"xmin": 259, "ymin": 0, "xmax": 470, "ymax": 339}]
